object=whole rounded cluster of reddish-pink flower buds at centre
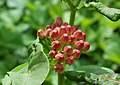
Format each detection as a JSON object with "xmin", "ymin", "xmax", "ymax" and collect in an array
[{"xmin": 38, "ymin": 17, "xmax": 90, "ymax": 73}]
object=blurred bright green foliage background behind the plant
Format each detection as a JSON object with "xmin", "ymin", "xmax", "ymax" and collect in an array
[{"xmin": 0, "ymin": 0, "xmax": 120, "ymax": 85}]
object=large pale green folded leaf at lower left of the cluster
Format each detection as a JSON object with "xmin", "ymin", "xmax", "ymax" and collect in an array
[{"xmin": 2, "ymin": 42, "xmax": 49, "ymax": 85}]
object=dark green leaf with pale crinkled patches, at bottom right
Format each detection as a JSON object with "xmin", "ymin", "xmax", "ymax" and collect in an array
[{"xmin": 64, "ymin": 65, "xmax": 120, "ymax": 85}]
